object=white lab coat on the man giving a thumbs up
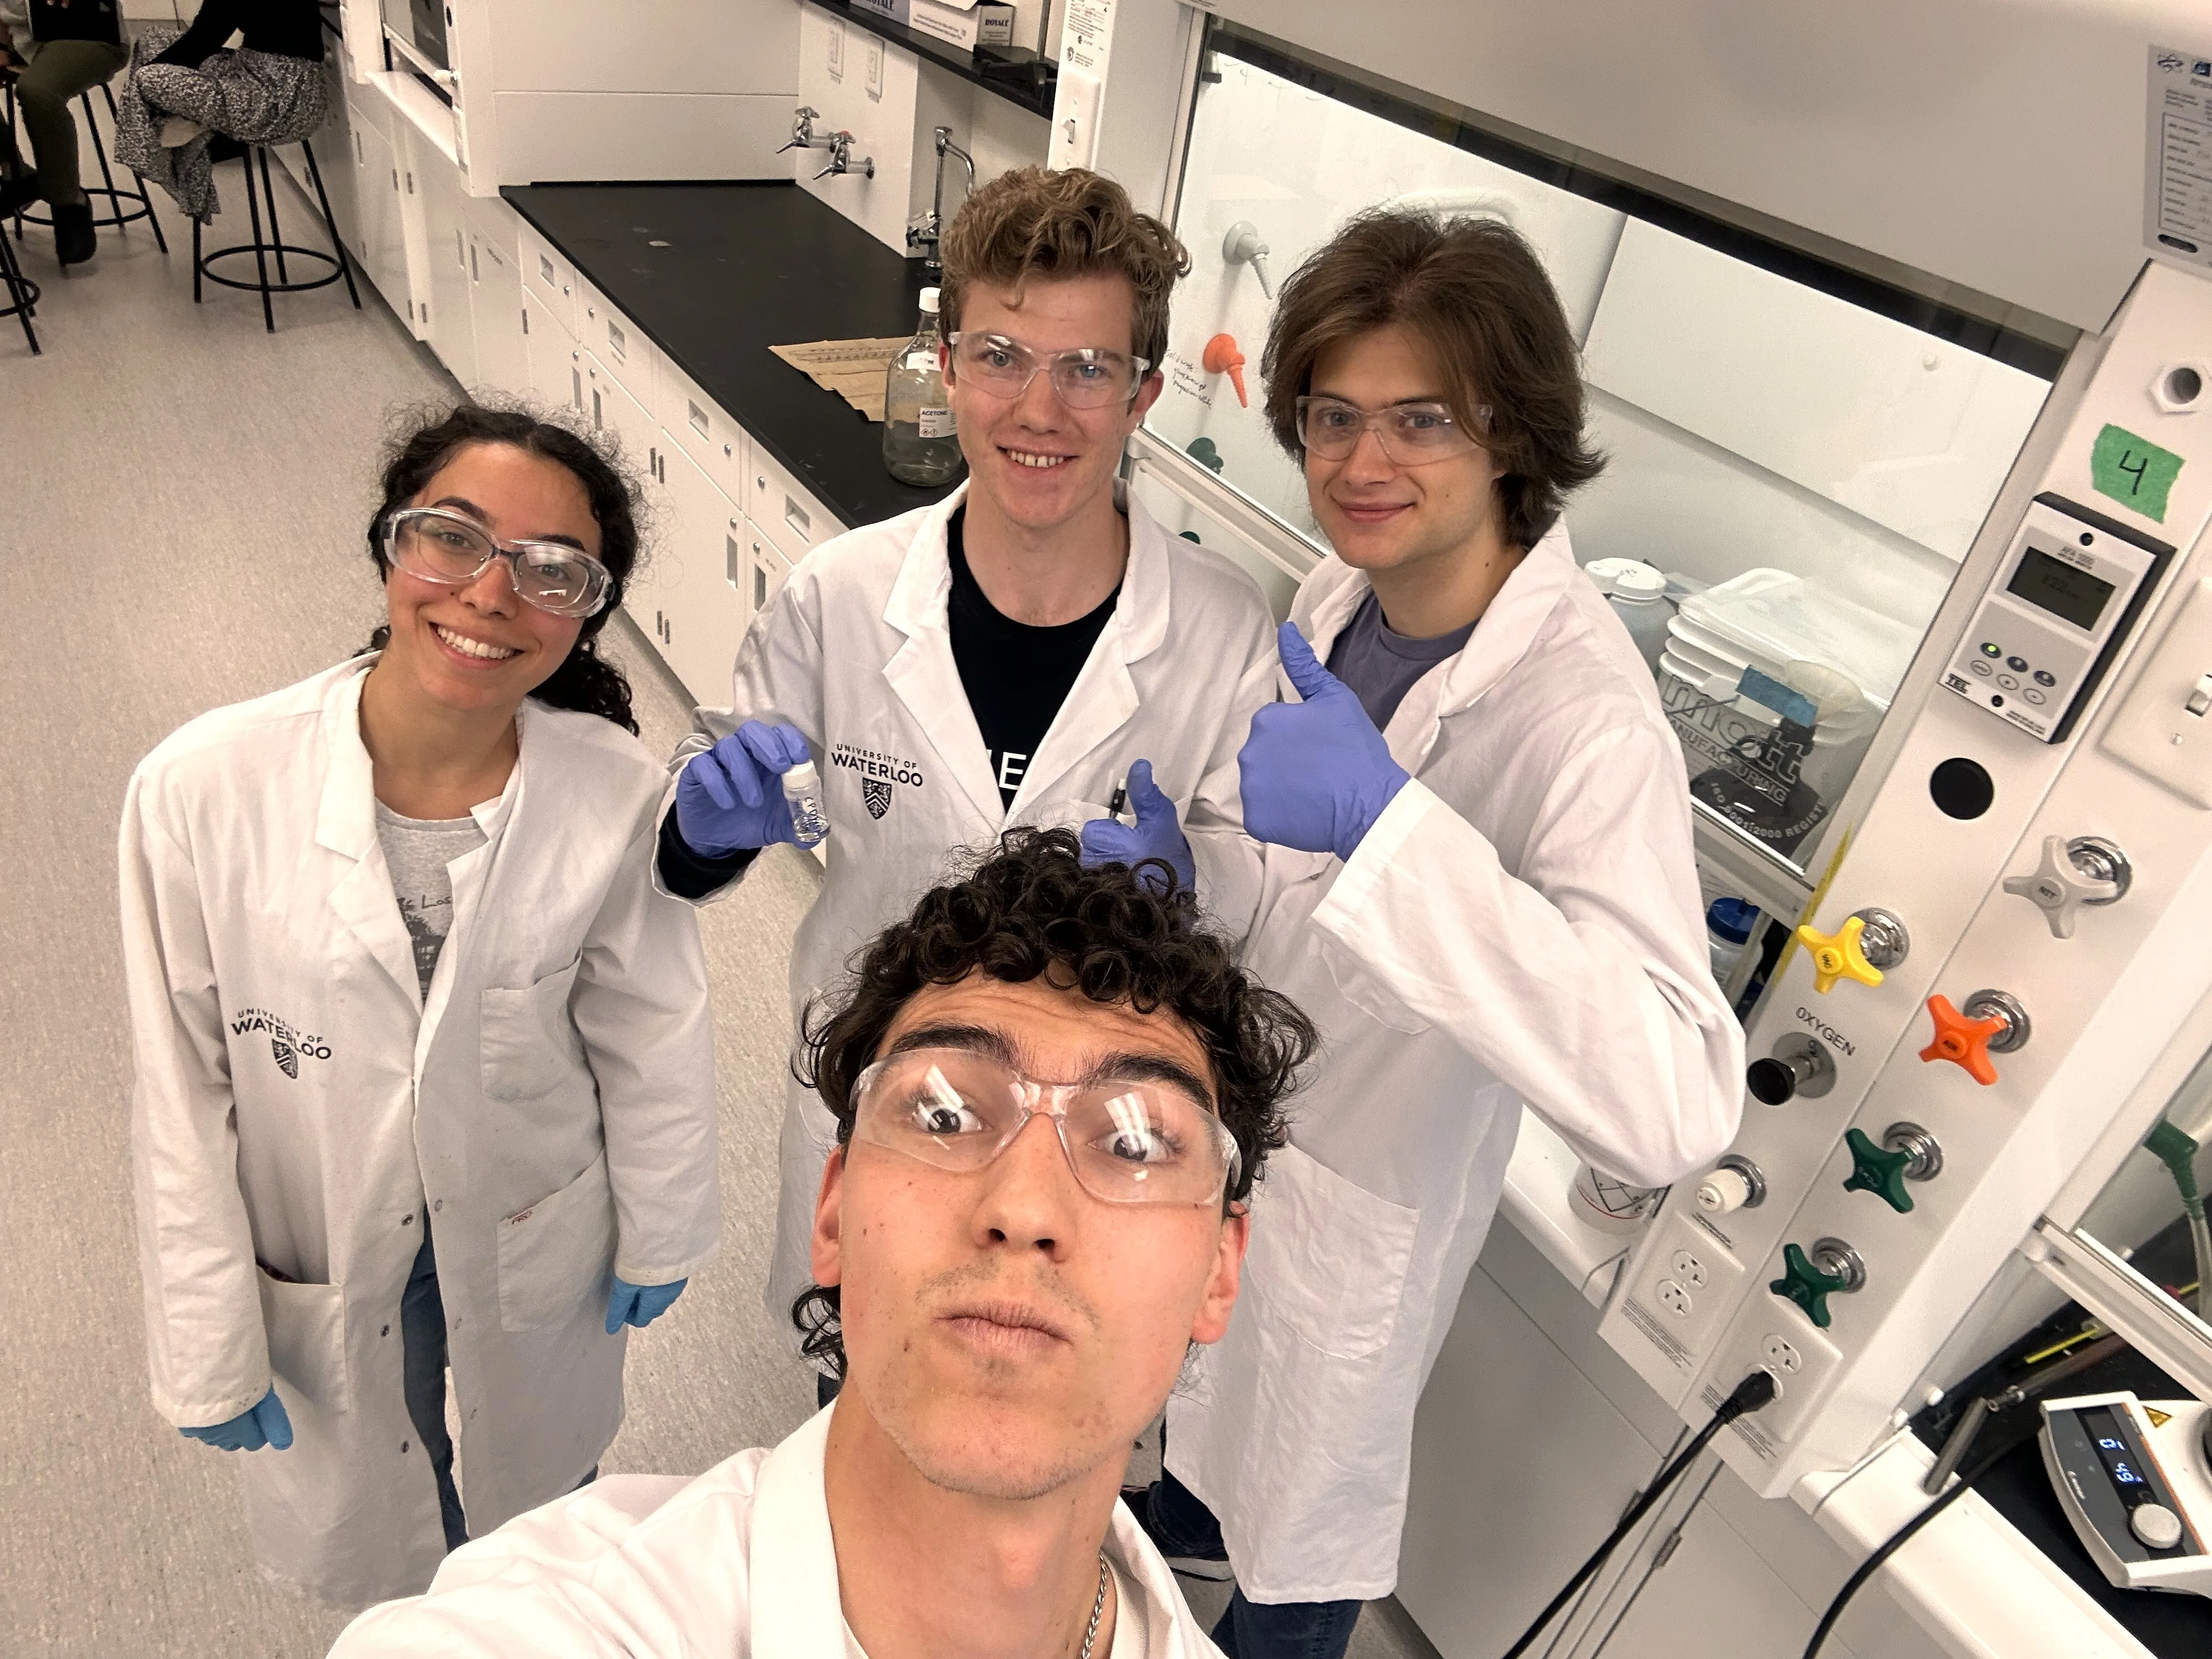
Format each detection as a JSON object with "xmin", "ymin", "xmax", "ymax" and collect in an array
[{"xmin": 1168, "ymin": 527, "xmax": 1743, "ymax": 1601}]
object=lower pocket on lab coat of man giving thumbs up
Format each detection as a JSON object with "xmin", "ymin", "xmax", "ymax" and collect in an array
[{"xmin": 1243, "ymin": 1146, "xmax": 1420, "ymax": 1361}]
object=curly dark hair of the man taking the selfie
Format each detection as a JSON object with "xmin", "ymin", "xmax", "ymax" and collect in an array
[{"xmin": 792, "ymin": 830, "xmax": 1318, "ymax": 1376}]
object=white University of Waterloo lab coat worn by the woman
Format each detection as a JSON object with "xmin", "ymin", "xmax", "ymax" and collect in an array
[{"xmin": 122, "ymin": 659, "xmax": 721, "ymax": 1606}]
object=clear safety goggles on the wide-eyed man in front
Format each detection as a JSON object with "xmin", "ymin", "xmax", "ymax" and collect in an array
[{"xmin": 851, "ymin": 1048, "xmax": 1239, "ymax": 1205}]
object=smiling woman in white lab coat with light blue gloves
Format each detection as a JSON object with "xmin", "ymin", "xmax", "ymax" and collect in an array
[{"xmin": 122, "ymin": 405, "xmax": 721, "ymax": 1606}]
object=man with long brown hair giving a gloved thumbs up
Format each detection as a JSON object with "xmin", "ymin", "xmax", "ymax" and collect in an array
[{"xmin": 1115, "ymin": 210, "xmax": 1743, "ymax": 1659}]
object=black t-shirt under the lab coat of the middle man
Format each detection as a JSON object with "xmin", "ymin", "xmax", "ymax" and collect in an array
[{"xmin": 945, "ymin": 506, "xmax": 1121, "ymax": 810}]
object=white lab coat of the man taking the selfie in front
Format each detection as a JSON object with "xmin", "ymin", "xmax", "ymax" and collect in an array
[{"xmin": 330, "ymin": 1407, "xmax": 1221, "ymax": 1659}]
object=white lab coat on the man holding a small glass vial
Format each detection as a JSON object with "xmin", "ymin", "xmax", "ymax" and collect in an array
[{"xmin": 670, "ymin": 484, "xmax": 1276, "ymax": 1342}]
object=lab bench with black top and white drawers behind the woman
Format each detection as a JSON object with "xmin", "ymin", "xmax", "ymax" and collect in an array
[{"xmin": 502, "ymin": 182, "xmax": 945, "ymax": 701}]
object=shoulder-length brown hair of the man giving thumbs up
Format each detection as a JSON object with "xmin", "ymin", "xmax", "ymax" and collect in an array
[{"xmin": 1261, "ymin": 208, "xmax": 1606, "ymax": 546}]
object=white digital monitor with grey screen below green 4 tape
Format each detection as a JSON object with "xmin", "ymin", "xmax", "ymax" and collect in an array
[{"xmin": 1942, "ymin": 495, "xmax": 2174, "ymax": 743}]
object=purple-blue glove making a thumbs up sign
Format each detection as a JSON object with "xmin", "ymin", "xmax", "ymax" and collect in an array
[{"xmin": 1237, "ymin": 622, "xmax": 1407, "ymax": 858}]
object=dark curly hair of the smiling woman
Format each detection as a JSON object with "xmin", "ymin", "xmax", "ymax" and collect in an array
[{"xmin": 363, "ymin": 403, "xmax": 644, "ymax": 737}]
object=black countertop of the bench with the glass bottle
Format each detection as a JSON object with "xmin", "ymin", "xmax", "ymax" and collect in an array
[{"xmin": 500, "ymin": 184, "xmax": 947, "ymax": 527}]
